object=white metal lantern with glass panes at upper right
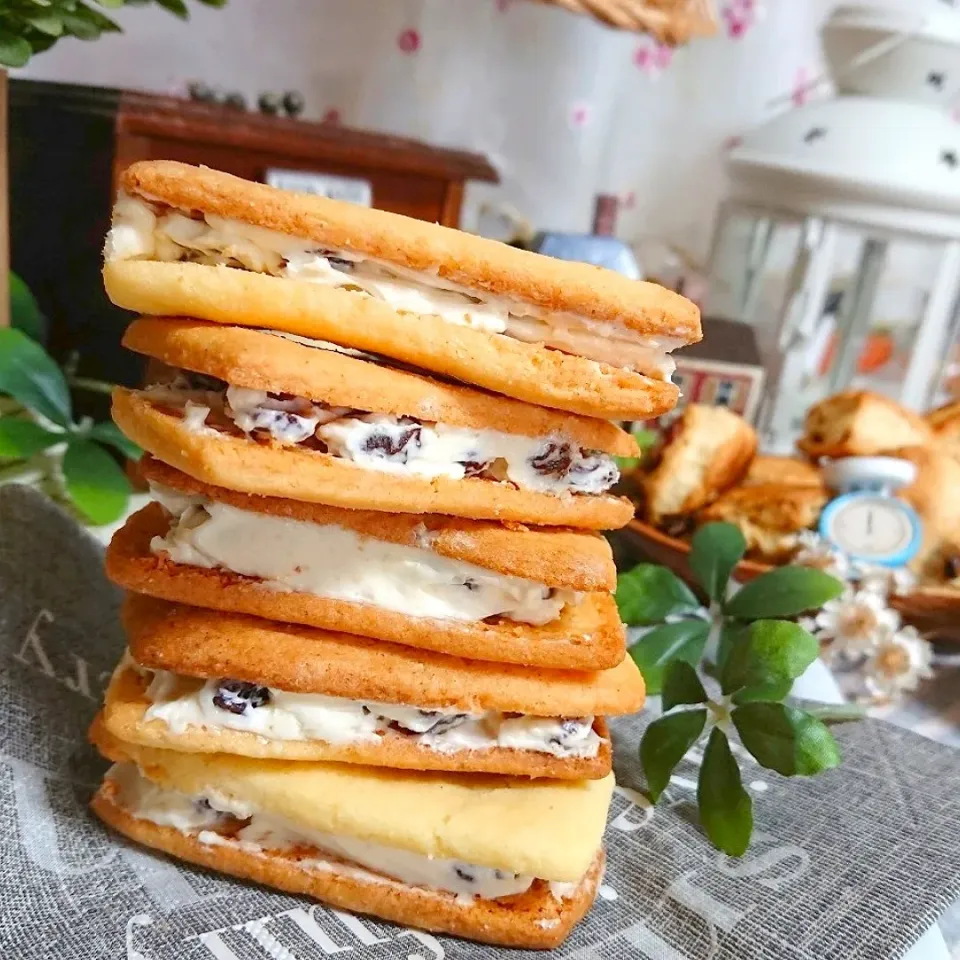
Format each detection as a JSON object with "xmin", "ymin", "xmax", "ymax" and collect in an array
[{"xmin": 706, "ymin": 0, "xmax": 960, "ymax": 450}]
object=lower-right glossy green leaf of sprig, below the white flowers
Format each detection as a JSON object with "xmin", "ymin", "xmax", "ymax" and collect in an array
[{"xmin": 732, "ymin": 703, "xmax": 840, "ymax": 777}]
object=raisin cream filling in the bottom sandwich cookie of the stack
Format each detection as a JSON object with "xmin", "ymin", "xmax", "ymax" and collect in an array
[{"xmin": 107, "ymin": 763, "xmax": 578, "ymax": 900}]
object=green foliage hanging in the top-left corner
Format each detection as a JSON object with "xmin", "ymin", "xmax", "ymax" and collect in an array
[{"xmin": 0, "ymin": 0, "xmax": 226, "ymax": 67}]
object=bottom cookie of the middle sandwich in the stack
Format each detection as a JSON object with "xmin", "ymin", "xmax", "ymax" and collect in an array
[{"xmin": 106, "ymin": 504, "xmax": 625, "ymax": 670}]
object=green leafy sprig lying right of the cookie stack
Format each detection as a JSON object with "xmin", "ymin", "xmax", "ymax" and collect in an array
[{"xmin": 617, "ymin": 523, "xmax": 850, "ymax": 856}]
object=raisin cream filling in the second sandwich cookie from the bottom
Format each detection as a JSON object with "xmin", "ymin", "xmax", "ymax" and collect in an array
[{"xmin": 140, "ymin": 668, "xmax": 602, "ymax": 758}]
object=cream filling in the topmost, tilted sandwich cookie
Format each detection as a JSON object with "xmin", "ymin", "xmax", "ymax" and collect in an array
[{"xmin": 104, "ymin": 194, "xmax": 685, "ymax": 380}]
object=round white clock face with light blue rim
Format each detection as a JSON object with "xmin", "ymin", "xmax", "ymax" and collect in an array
[{"xmin": 821, "ymin": 493, "xmax": 920, "ymax": 564}]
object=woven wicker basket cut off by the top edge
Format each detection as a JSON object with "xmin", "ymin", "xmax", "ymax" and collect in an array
[{"xmin": 528, "ymin": 0, "xmax": 717, "ymax": 46}]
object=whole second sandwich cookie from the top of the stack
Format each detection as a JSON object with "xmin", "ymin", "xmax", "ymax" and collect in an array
[{"xmin": 116, "ymin": 318, "xmax": 636, "ymax": 528}]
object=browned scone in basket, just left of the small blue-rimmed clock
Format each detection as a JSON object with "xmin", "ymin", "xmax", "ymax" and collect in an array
[{"xmin": 697, "ymin": 483, "xmax": 829, "ymax": 563}]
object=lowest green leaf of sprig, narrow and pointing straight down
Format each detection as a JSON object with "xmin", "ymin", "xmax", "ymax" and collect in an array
[{"xmin": 697, "ymin": 727, "xmax": 753, "ymax": 857}]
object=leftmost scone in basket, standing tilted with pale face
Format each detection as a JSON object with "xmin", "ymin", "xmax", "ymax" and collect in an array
[{"xmin": 643, "ymin": 404, "xmax": 757, "ymax": 525}]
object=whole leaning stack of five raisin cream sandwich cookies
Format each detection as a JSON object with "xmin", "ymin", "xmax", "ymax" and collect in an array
[{"xmin": 91, "ymin": 162, "xmax": 699, "ymax": 948}]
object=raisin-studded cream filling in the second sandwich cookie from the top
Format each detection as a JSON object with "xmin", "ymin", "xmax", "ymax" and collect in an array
[{"xmin": 143, "ymin": 371, "xmax": 620, "ymax": 496}]
